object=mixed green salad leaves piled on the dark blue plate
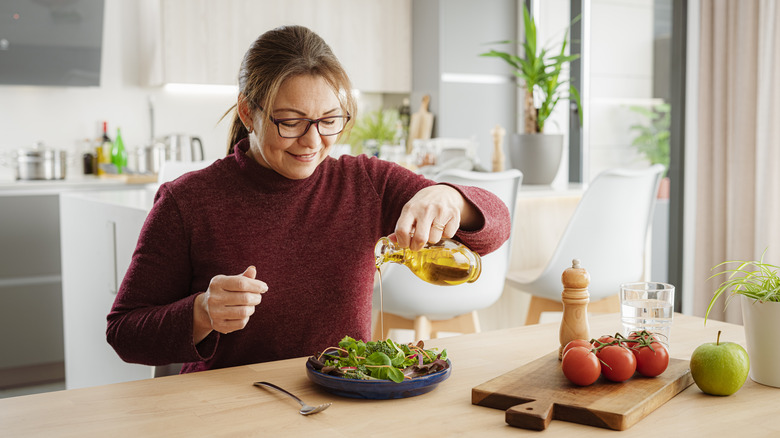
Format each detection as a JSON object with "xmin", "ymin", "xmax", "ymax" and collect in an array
[{"xmin": 309, "ymin": 336, "xmax": 449, "ymax": 383}]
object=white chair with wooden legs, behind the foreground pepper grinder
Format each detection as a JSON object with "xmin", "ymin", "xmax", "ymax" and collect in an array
[{"xmin": 506, "ymin": 164, "xmax": 664, "ymax": 324}]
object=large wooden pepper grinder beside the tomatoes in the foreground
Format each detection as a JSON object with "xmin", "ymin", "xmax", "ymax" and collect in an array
[{"xmin": 558, "ymin": 259, "xmax": 590, "ymax": 360}]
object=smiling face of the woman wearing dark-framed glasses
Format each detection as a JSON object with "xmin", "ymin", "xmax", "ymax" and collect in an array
[{"xmin": 245, "ymin": 75, "xmax": 345, "ymax": 179}]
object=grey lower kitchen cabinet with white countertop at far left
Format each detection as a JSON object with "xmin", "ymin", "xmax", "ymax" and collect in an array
[{"xmin": 0, "ymin": 178, "xmax": 145, "ymax": 387}]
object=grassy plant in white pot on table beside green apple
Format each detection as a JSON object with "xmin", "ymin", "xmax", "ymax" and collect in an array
[{"xmin": 704, "ymin": 251, "xmax": 780, "ymax": 387}]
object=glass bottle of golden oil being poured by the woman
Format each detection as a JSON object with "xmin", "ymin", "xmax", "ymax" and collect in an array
[{"xmin": 374, "ymin": 237, "xmax": 482, "ymax": 286}]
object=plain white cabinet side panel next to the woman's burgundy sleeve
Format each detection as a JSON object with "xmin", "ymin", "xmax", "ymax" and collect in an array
[{"xmin": 60, "ymin": 188, "xmax": 154, "ymax": 389}]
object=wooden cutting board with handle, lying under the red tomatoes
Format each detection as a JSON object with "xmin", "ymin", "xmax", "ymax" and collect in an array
[{"xmin": 471, "ymin": 351, "xmax": 693, "ymax": 430}]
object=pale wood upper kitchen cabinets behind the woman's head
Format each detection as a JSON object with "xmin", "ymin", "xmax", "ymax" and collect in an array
[{"xmin": 139, "ymin": 0, "xmax": 412, "ymax": 93}]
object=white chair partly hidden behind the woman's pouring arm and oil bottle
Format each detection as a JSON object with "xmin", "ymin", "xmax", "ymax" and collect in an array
[{"xmin": 373, "ymin": 169, "xmax": 523, "ymax": 340}]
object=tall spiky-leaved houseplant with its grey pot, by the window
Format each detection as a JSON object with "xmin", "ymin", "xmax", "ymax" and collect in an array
[{"xmin": 480, "ymin": 4, "xmax": 582, "ymax": 184}]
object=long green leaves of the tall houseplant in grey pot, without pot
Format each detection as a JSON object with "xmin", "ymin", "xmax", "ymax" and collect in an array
[{"xmin": 480, "ymin": 5, "xmax": 582, "ymax": 134}]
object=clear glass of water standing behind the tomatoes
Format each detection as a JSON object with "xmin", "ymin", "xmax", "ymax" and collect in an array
[{"xmin": 620, "ymin": 281, "xmax": 674, "ymax": 349}]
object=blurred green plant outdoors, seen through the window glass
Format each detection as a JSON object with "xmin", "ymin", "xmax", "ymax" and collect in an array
[{"xmin": 629, "ymin": 103, "xmax": 672, "ymax": 199}]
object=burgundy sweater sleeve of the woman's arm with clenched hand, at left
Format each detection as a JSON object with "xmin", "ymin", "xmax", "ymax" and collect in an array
[{"xmin": 106, "ymin": 185, "xmax": 218, "ymax": 365}]
